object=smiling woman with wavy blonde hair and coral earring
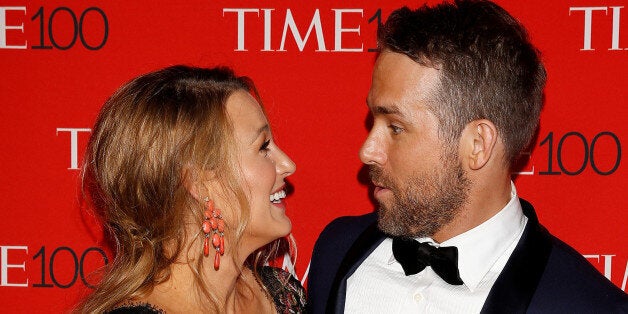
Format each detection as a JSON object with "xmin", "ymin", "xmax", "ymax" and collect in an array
[{"xmin": 77, "ymin": 66, "xmax": 305, "ymax": 313}]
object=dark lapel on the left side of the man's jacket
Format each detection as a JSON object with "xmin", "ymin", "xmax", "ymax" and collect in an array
[{"xmin": 325, "ymin": 222, "xmax": 386, "ymax": 313}]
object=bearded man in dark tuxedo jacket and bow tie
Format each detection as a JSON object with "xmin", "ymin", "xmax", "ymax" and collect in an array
[{"xmin": 308, "ymin": 1, "xmax": 628, "ymax": 313}]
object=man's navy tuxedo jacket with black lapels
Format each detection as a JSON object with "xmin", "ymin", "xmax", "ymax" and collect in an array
[{"xmin": 307, "ymin": 200, "xmax": 628, "ymax": 314}]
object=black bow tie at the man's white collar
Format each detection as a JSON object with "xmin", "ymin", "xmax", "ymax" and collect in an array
[{"xmin": 393, "ymin": 238, "xmax": 463, "ymax": 285}]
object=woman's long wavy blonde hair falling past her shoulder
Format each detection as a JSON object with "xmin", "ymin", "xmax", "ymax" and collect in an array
[{"xmin": 76, "ymin": 65, "xmax": 290, "ymax": 313}]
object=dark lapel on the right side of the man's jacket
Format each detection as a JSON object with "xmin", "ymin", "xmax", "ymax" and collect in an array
[{"xmin": 481, "ymin": 200, "xmax": 552, "ymax": 313}]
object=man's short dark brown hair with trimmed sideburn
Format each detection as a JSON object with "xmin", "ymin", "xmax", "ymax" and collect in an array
[{"xmin": 378, "ymin": 0, "xmax": 546, "ymax": 165}]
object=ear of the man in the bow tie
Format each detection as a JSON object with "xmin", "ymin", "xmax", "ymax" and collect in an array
[{"xmin": 461, "ymin": 119, "xmax": 498, "ymax": 170}]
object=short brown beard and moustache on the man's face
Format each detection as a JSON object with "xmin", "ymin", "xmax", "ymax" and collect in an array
[{"xmin": 369, "ymin": 157, "xmax": 470, "ymax": 238}]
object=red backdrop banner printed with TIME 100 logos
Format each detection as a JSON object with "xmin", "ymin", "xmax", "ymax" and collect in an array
[{"xmin": 0, "ymin": 0, "xmax": 628, "ymax": 312}]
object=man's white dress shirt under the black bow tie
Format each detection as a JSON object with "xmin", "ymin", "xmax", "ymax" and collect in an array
[{"xmin": 345, "ymin": 184, "xmax": 528, "ymax": 313}]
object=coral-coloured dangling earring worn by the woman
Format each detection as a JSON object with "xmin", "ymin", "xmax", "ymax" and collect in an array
[{"xmin": 203, "ymin": 197, "xmax": 225, "ymax": 270}]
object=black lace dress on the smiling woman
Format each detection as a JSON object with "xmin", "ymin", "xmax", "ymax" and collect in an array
[{"xmin": 108, "ymin": 266, "xmax": 306, "ymax": 314}]
